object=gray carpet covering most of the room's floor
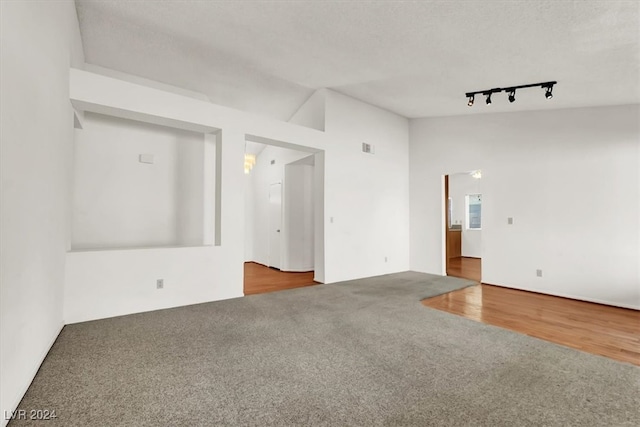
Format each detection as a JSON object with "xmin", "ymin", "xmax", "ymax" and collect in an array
[{"xmin": 10, "ymin": 272, "xmax": 640, "ymax": 426}]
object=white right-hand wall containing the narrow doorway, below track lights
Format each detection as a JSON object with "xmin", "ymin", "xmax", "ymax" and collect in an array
[{"xmin": 410, "ymin": 105, "xmax": 640, "ymax": 308}]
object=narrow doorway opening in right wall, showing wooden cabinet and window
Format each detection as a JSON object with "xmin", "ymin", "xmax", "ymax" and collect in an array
[{"xmin": 443, "ymin": 169, "xmax": 482, "ymax": 283}]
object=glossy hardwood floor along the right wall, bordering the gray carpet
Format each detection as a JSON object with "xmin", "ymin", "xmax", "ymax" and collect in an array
[{"xmin": 422, "ymin": 284, "xmax": 640, "ymax": 366}]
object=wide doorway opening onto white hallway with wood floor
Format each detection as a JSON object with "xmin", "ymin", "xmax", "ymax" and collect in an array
[{"xmin": 244, "ymin": 135, "xmax": 324, "ymax": 295}]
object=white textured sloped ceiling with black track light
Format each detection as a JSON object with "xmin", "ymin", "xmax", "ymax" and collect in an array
[{"xmin": 76, "ymin": 0, "xmax": 640, "ymax": 120}]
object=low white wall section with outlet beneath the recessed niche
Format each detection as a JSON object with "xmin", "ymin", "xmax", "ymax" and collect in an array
[{"xmin": 64, "ymin": 246, "xmax": 242, "ymax": 323}]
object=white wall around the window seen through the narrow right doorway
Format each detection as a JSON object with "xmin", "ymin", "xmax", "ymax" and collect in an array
[{"xmin": 449, "ymin": 173, "xmax": 484, "ymax": 258}]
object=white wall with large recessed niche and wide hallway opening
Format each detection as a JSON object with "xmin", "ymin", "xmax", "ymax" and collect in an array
[{"xmin": 65, "ymin": 70, "xmax": 409, "ymax": 322}]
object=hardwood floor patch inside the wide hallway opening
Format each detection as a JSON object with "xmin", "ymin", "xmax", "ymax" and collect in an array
[{"xmin": 244, "ymin": 262, "xmax": 318, "ymax": 295}]
